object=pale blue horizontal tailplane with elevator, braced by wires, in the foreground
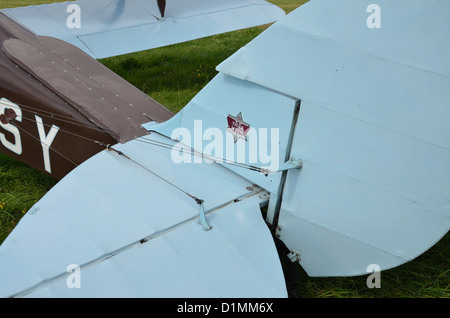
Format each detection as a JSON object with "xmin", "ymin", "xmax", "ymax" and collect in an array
[{"xmin": 0, "ymin": 134, "xmax": 287, "ymax": 297}]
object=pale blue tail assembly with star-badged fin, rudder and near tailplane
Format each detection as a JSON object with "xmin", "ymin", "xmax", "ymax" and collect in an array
[{"xmin": 0, "ymin": 0, "xmax": 450, "ymax": 297}]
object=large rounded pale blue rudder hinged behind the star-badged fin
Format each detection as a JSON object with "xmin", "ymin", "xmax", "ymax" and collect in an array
[{"xmin": 218, "ymin": 0, "xmax": 450, "ymax": 276}]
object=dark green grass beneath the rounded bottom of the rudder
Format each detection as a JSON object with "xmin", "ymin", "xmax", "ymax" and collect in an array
[{"xmin": 296, "ymin": 234, "xmax": 450, "ymax": 298}]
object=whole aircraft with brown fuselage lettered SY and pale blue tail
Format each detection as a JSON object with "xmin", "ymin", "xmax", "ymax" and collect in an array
[{"xmin": 0, "ymin": 0, "xmax": 450, "ymax": 298}]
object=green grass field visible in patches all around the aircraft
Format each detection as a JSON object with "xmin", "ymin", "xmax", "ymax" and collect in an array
[{"xmin": 0, "ymin": 0, "xmax": 450, "ymax": 298}]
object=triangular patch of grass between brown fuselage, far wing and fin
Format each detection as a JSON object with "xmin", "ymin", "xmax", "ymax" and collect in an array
[{"xmin": 101, "ymin": 27, "xmax": 263, "ymax": 112}]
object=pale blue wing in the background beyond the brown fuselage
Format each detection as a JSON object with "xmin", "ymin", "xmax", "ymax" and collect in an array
[{"xmin": 3, "ymin": 0, "xmax": 285, "ymax": 59}]
